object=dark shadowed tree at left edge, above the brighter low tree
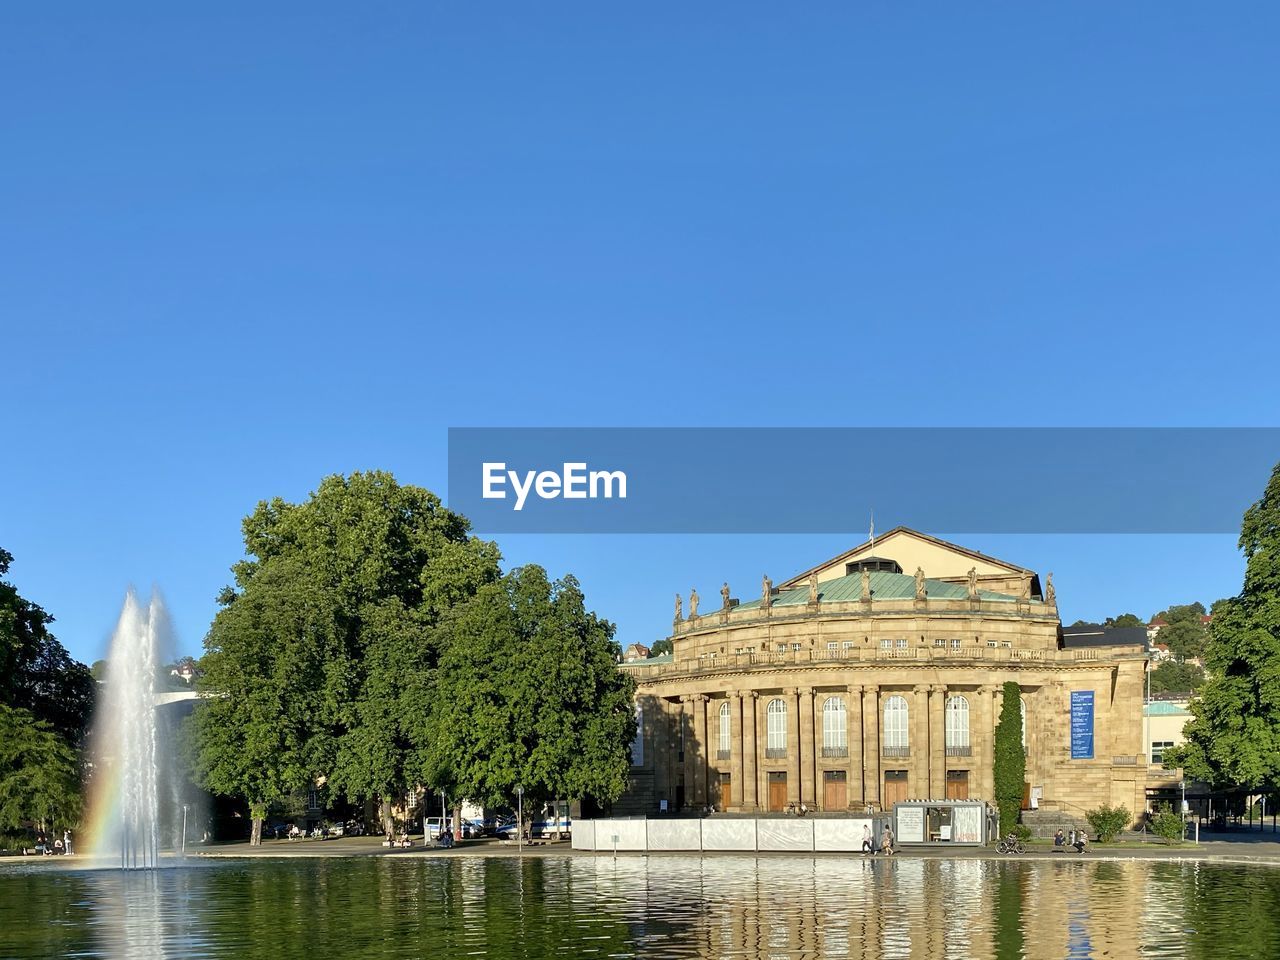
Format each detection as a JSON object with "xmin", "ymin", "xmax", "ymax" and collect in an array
[{"xmin": 0, "ymin": 549, "xmax": 97, "ymax": 746}]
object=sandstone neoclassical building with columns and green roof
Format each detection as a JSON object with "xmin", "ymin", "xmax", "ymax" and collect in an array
[{"xmin": 616, "ymin": 527, "xmax": 1147, "ymax": 818}]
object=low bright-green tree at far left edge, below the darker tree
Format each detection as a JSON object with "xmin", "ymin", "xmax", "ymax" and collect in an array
[{"xmin": 0, "ymin": 704, "xmax": 83, "ymax": 829}]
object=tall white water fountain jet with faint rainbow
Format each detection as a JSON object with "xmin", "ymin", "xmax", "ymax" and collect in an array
[{"xmin": 90, "ymin": 590, "xmax": 165, "ymax": 869}]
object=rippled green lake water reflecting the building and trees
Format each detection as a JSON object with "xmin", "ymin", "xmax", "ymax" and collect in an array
[{"xmin": 0, "ymin": 856, "xmax": 1280, "ymax": 960}]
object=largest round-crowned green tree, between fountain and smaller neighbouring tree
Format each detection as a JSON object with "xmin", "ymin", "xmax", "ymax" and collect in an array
[{"xmin": 193, "ymin": 471, "xmax": 499, "ymax": 827}]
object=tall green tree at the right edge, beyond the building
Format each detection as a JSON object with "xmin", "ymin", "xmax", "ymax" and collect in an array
[{"xmin": 1161, "ymin": 465, "xmax": 1280, "ymax": 788}]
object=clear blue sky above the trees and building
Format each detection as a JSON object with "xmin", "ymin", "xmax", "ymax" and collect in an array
[{"xmin": 0, "ymin": 3, "xmax": 1280, "ymax": 660}]
